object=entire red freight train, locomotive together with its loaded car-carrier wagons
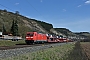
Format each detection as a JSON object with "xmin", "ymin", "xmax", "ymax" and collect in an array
[{"xmin": 25, "ymin": 32, "xmax": 69, "ymax": 44}]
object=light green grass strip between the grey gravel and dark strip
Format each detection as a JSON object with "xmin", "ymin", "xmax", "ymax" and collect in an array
[{"xmin": 2, "ymin": 43, "xmax": 74, "ymax": 60}]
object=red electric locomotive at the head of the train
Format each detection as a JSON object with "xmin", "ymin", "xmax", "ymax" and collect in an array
[{"xmin": 25, "ymin": 32, "xmax": 47, "ymax": 44}]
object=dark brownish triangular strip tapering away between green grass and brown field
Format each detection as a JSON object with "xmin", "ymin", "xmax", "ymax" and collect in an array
[{"xmin": 64, "ymin": 42, "xmax": 88, "ymax": 60}]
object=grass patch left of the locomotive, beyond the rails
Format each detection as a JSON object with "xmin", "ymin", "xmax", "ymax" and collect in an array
[{"xmin": 0, "ymin": 40, "xmax": 25, "ymax": 46}]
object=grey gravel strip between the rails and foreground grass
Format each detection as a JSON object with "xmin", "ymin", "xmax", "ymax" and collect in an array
[{"xmin": 0, "ymin": 43, "xmax": 66, "ymax": 58}]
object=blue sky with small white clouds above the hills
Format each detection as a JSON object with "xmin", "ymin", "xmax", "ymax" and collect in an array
[{"xmin": 0, "ymin": 0, "xmax": 90, "ymax": 32}]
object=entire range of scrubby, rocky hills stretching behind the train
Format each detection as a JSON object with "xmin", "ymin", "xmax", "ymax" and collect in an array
[{"xmin": 0, "ymin": 10, "xmax": 90, "ymax": 37}]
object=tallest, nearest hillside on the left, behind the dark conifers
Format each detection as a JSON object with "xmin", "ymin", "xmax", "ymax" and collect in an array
[{"xmin": 0, "ymin": 10, "xmax": 53, "ymax": 37}]
